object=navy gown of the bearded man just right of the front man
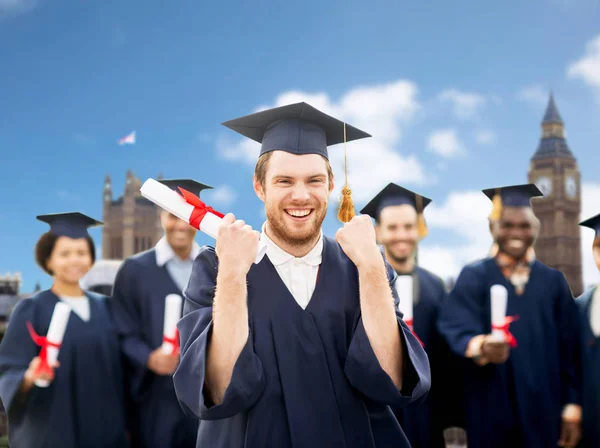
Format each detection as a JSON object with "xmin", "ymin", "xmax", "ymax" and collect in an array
[{"xmin": 395, "ymin": 266, "xmax": 464, "ymax": 448}]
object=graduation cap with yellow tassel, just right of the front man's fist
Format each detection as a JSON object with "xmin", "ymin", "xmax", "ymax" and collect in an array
[{"xmin": 360, "ymin": 182, "xmax": 431, "ymax": 238}]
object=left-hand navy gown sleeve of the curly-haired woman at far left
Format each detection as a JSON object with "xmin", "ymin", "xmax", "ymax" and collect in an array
[{"xmin": 0, "ymin": 299, "xmax": 39, "ymax": 416}]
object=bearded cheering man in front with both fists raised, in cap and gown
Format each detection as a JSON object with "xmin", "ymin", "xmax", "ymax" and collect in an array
[{"xmin": 174, "ymin": 103, "xmax": 430, "ymax": 448}]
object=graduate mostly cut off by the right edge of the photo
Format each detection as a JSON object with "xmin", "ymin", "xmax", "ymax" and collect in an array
[{"xmin": 577, "ymin": 215, "xmax": 600, "ymax": 448}]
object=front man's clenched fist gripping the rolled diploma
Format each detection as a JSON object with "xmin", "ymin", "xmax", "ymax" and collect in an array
[{"xmin": 215, "ymin": 213, "xmax": 260, "ymax": 275}]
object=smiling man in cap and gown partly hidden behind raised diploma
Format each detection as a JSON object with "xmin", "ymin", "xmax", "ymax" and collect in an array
[{"xmin": 113, "ymin": 179, "xmax": 212, "ymax": 448}]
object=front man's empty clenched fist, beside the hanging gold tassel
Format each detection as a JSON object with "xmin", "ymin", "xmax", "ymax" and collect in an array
[{"xmin": 335, "ymin": 215, "xmax": 383, "ymax": 268}]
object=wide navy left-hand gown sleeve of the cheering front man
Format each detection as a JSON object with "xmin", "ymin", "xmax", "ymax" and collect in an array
[{"xmin": 173, "ymin": 246, "xmax": 266, "ymax": 420}]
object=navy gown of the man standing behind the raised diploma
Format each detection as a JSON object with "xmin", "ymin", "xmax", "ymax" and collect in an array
[{"xmin": 112, "ymin": 249, "xmax": 198, "ymax": 448}]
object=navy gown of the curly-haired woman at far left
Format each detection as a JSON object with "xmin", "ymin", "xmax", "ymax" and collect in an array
[{"xmin": 0, "ymin": 290, "xmax": 129, "ymax": 448}]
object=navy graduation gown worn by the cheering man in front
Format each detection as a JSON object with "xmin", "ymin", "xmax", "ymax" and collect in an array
[{"xmin": 174, "ymin": 237, "xmax": 430, "ymax": 448}]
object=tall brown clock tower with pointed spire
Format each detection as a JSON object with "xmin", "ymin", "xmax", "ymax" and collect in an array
[{"xmin": 528, "ymin": 94, "xmax": 583, "ymax": 297}]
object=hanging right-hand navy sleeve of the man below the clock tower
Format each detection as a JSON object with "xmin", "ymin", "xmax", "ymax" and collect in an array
[{"xmin": 558, "ymin": 272, "xmax": 582, "ymax": 405}]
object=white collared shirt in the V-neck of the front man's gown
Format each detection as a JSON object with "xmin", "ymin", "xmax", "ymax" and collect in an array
[{"xmin": 260, "ymin": 223, "xmax": 323, "ymax": 309}]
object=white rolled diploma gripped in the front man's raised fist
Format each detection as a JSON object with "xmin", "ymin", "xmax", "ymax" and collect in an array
[{"xmin": 140, "ymin": 179, "xmax": 267, "ymax": 263}]
